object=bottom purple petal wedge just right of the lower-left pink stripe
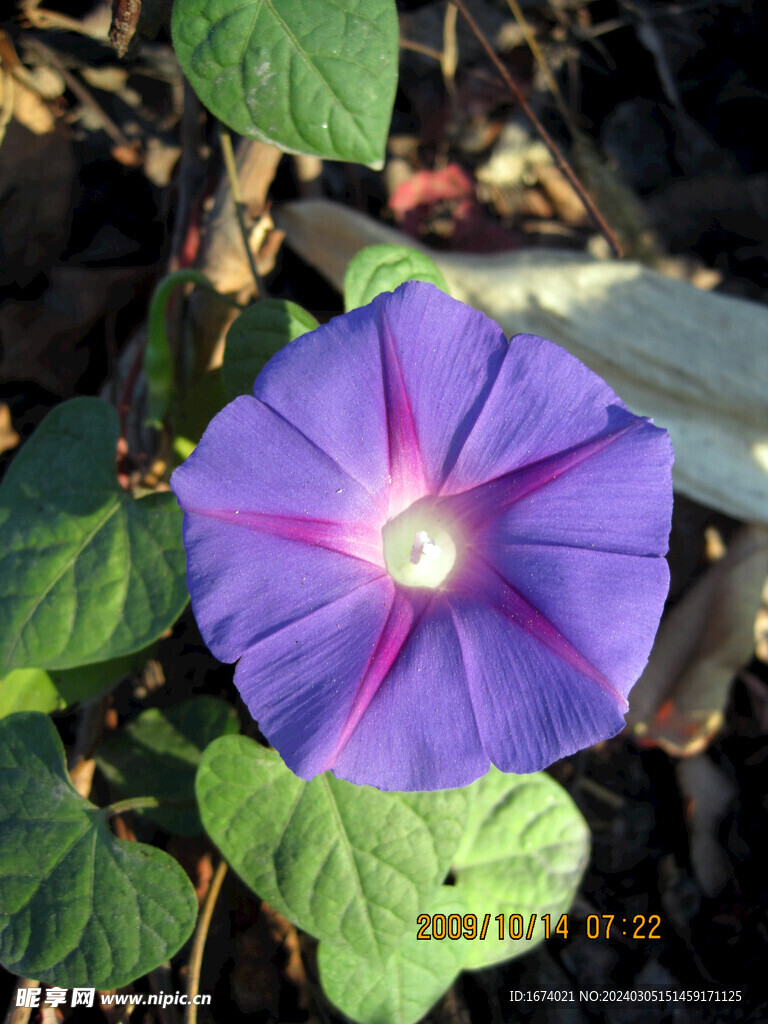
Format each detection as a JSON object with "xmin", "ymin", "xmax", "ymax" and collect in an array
[{"xmin": 333, "ymin": 595, "xmax": 489, "ymax": 791}]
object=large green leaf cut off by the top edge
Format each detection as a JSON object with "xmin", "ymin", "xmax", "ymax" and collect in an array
[{"xmin": 171, "ymin": 0, "xmax": 398, "ymax": 167}]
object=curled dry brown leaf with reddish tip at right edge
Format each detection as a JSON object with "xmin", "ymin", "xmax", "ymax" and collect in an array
[{"xmin": 628, "ymin": 525, "xmax": 768, "ymax": 756}]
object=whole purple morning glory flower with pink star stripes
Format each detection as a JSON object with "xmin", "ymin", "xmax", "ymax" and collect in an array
[{"xmin": 171, "ymin": 283, "xmax": 673, "ymax": 791}]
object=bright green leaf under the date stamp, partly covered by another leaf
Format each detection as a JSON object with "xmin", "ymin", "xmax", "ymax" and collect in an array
[{"xmin": 317, "ymin": 768, "xmax": 589, "ymax": 1024}]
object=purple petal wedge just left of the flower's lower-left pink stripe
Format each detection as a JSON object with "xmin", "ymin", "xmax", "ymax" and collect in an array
[{"xmin": 234, "ymin": 577, "xmax": 399, "ymax": 778}]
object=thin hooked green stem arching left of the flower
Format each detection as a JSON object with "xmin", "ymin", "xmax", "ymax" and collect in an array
[{"xmin": 144, "ymin": 269, "xmax": 242, "ymax": 430}]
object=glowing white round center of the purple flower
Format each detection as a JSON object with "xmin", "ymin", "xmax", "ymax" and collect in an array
[{"xmin": 382, "ymin": 501, "xmax": 456, "ymax": 590}]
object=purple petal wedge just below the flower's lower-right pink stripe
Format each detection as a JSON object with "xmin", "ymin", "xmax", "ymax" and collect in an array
[{"xmin": 452, "ymin": 597, "xmax": 624, "ymax": 773}]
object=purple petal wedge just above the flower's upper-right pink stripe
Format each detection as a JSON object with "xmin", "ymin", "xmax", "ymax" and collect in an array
[{"xmin": 442, "ymin": 334, "xmax": 636, "ymax": 494}]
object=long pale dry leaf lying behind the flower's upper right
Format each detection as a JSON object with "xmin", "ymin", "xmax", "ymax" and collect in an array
[{"xmin": 275, "ymin": 200, "xmax": 768, "ymax": 524}]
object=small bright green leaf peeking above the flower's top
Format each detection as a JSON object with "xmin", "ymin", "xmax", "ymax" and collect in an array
[{"xmin": 344, "ymin": 246, "xmax": 449, "ymax": 310}]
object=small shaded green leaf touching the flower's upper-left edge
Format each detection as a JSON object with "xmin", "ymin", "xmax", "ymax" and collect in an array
[{"xmin": 221, "ymin": 299, "xmax": 317, "ymax": 399}]
